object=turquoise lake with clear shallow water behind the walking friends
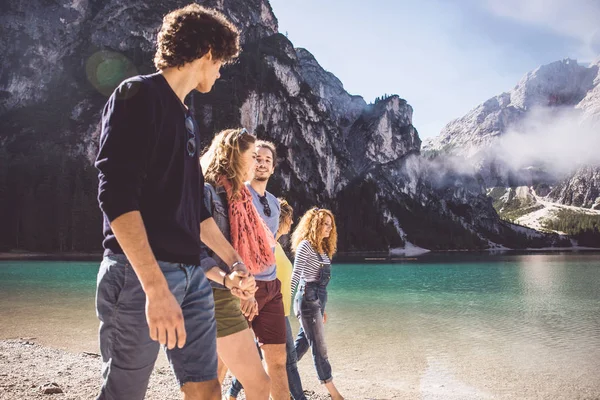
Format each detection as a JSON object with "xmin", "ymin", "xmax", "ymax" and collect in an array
[{"xmin": 0, "ymin": 253, "xmax": 600, "ymax": 399}]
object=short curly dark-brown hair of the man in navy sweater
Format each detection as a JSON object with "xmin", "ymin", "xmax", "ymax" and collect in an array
[{"xmin": 154, "ymin": 4, "xmax": 240, "ymax": 70}]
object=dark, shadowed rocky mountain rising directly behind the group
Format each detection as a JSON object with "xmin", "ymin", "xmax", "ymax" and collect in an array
[{"xmin": 0, "ymin": 0, "xmax": 564, "ymax": 252}]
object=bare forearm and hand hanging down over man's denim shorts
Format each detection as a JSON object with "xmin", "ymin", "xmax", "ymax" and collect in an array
[{"xmin": 110, "ymin": 211, "xmax": 186, "ymax": 349}]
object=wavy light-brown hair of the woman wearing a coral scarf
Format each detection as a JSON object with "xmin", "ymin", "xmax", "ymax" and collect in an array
[{"xmin": 200, "ymin": 129, "xmax": 256, "ymax": 200}]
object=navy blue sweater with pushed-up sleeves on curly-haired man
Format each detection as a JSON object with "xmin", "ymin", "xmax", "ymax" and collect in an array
[{"xmin": 95, "ymin": 74, "xmax": 210, "ymax": 265}]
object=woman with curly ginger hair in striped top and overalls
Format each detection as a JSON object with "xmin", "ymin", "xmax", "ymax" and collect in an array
[{"xmin": 292, "ymin": 208, "xmax": 344, "ymax": 400}]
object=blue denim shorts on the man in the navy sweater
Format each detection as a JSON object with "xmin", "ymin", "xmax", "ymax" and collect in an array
[{"xmin": 96, "ymin": 254, "xmax": 217, "ymax": 400}]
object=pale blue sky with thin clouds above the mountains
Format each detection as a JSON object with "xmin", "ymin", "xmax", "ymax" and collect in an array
[{"xmin": 270, "ymin": 0, "xmax": 600, "ymax": 139}]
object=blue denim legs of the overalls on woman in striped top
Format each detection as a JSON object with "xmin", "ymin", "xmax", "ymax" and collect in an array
[{"xmin": 294, "ymin": 271, "xmax": 333, "ymax": 383}]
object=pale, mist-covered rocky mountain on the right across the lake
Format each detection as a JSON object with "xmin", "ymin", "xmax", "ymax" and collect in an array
[{"xmin": 424, "ymin": 59, "xmax": 600, "ymax": 243}]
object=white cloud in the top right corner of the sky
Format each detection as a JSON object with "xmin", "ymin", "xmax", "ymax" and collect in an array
[{"xmin": 483, "ymin": 0, "xmax": 600, "ymax": 60}]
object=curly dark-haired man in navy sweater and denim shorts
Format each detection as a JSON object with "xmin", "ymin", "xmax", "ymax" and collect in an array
[{"xmin": 95, "ymin": 4, "xmax": 250, "ymax": 400}]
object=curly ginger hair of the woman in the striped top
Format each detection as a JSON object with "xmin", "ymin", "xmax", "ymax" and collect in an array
[{"xmin": 292, "ymin": 207, "xmax": 337, "ymax": 258}]
